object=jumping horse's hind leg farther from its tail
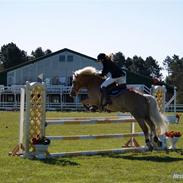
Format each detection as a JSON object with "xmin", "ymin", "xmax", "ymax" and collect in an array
[{"xmin": 134, "ymin": 116, "xmax": 153, "ymax": 151}]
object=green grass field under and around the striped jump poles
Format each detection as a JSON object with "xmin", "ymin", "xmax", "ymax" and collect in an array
[{"xmin": 0, "ymin": 112, "xmax": 183, "ymax": 183}]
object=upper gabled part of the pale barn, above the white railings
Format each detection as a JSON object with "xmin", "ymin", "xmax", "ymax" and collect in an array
[{"xmin": 4, "ymin": 48, "xmax": 101, "ymax": 85}]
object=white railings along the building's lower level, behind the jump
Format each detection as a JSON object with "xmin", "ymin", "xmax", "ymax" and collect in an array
[{"xmin": 0, "ymin": 85, "xmax": 183, "ymax": 112}]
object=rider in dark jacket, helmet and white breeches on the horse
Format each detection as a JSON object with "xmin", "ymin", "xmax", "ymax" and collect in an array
[{"xmin": 97, "ymin": 53, "xmax": 126, "ymax": 106}]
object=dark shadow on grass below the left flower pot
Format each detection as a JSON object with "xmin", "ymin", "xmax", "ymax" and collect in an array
[{"xmin": 34, "ymin": 158, "xmax": 80, "ymax": 166}]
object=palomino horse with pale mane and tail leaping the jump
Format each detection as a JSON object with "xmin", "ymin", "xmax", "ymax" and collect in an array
[{"xmin": 70, "ymin": 67, "xmax": 168, "ymax": 150}]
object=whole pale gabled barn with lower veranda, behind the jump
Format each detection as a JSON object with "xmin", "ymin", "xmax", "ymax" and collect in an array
[{"xmin": 0, "ymin": 48, "xmax": 102, "ymax": 109}]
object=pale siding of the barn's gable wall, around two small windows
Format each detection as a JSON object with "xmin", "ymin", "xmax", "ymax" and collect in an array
[{"xmin": 7, "ymin": 51, "xmax": 102, "ymax": 85}]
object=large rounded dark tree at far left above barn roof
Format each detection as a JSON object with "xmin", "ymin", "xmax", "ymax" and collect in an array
[{"xmin": 0, "ymin": 43, "xmax": 28, "ymax": 68}]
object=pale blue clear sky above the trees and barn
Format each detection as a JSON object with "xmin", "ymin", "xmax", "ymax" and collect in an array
[{"xmin": 0, "ymin": 0, "xmax": 183, "ymax": 75}]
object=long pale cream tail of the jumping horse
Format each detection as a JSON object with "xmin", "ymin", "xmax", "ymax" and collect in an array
[{"xmin": 145, "ymin": 95, "xmax": 168, "ymax": 135}]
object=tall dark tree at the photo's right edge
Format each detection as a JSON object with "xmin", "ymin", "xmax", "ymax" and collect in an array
[{"xmin": 163, "ymin": 55, "xmax": 183, "ymax": 103}]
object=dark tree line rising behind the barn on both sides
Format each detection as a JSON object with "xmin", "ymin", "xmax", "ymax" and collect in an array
[{"xmin": 0, "ymin": 43, "xmax": 183, "ymax": 103}]
